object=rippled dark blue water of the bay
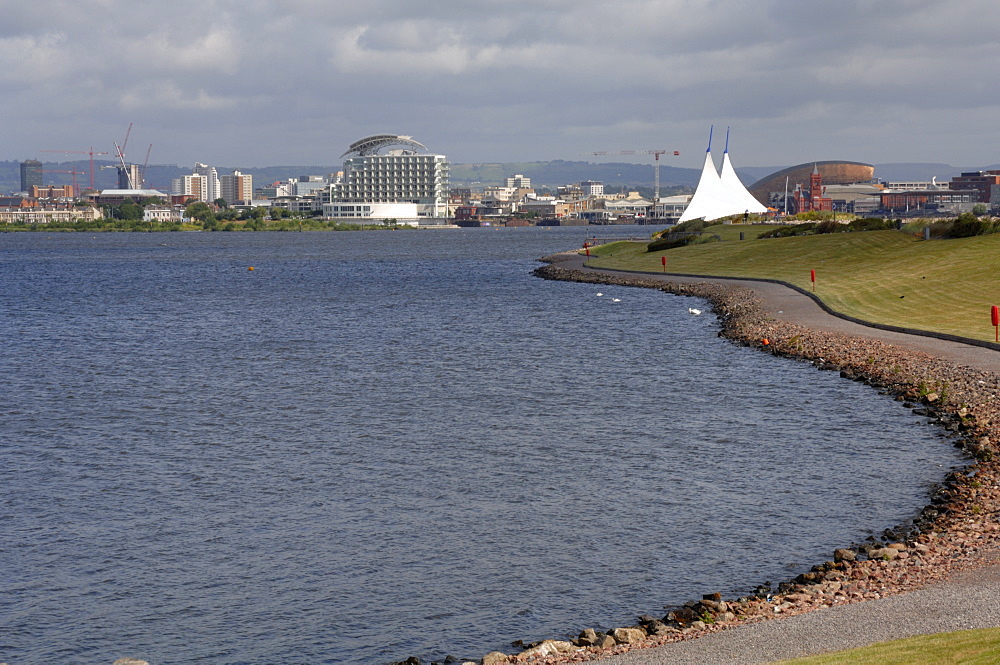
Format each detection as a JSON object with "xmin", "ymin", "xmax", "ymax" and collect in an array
[{"xmin": 0, "ymin": 228, "xmax": 960, "ymax": 665}]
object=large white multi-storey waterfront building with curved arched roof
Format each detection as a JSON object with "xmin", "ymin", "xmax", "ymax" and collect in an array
[{"xmin": 328, "ymin": 134, "xmax": 450, "ymax": 219}]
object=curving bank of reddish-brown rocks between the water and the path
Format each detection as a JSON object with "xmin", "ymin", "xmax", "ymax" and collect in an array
[{"xmin": 436, "ymin": 255, "xmax": 1000, "ymax": 665}]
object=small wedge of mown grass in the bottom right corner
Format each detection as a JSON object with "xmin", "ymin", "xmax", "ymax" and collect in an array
[{"xmin": 781, "ymin": 628, "xmax": 1000, "ymax": 665}]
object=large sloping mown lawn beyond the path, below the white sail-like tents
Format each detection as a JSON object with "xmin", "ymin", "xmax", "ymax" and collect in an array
[{"xmin": 589, "ymin": 225, "xmax": 1000, "ymax": 341}]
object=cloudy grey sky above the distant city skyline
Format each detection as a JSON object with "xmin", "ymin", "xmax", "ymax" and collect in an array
[{"xmin": 7, "ymin": 0, "xmax": 1000, "ymax": 168}]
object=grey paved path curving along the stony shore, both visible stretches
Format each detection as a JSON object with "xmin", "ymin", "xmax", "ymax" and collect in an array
[{"xmin": 558, "ymin": 257, "xmax": 1000, "ymax": 665}]
